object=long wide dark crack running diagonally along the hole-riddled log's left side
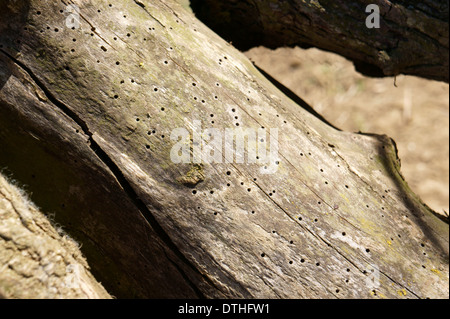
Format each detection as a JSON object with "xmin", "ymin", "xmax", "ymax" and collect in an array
[{"xmin": 0, "ymin": 49, "xmax": 216, "ymax": 299}]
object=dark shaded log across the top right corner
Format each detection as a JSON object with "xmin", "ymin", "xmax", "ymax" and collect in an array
[{"xmin": 191, "ymin": 0, "xmax": 449, "ymax": 83}]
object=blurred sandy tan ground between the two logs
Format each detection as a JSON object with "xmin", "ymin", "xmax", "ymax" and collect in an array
[{"xmin": 246, "ymin": 48, "xmax": 449, "ymax": 218}]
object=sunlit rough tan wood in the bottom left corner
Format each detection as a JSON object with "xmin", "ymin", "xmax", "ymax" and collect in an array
[{"xmin": 0, "ymin": 174, "xmax": 111, "ymax": 299}]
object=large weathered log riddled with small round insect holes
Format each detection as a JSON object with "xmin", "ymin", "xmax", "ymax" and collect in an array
[{"xmin": 0, "ymin": 0, "xmax": 449, "ymax": 298}]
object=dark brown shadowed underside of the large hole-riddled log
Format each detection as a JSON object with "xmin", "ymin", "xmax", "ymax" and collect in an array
[{"xmin": 0, "ymin": 60, "xmax": 202, "ymax": 298}]
